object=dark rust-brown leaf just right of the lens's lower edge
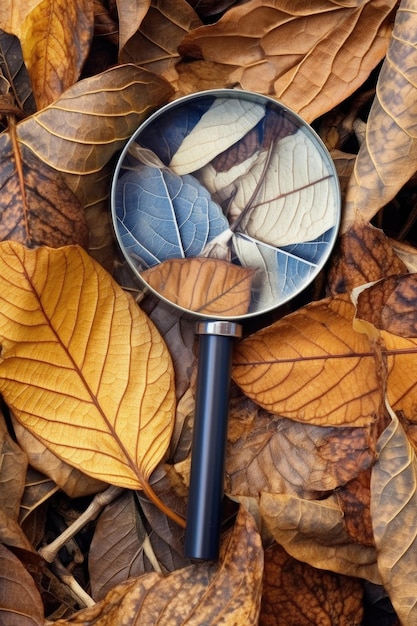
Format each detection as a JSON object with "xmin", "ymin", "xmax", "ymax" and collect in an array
[{"xmin": 328, "ymin": 218, "xmax": 407, "ymax": 293}]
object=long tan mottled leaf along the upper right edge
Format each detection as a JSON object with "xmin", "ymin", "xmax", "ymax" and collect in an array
[{"xmin": 344, "ymin": 0, "xmax": 417, "ymax": 228}]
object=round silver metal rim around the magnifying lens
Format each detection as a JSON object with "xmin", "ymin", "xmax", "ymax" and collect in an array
[{"xmin": 110, "ymin": 88, "xmax": 341, "ymax": 321}]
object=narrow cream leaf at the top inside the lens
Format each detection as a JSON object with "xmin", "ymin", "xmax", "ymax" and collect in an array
[{"xmin": 169, "ymin": 98, "xmax": 265, "ymax": 174}]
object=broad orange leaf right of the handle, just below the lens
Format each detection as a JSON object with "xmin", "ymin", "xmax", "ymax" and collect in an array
[{"xmin": 232, "ymin": 296, "xmax": 382, "ymax": 426}]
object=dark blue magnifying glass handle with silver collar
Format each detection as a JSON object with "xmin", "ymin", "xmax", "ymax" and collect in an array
[{"xmin": 184, "ymin": 321, "xmax": 242, "ymax": 560}]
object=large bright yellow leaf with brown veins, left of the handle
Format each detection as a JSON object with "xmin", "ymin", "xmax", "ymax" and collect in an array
[{"xmin": 0, "ymin": 242, "xmax": 175, "ymax": 489}]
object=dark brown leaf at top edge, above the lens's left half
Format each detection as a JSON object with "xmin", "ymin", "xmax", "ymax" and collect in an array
[{"xmin": 119, "ymin": 0, "xmax": 202, "ymax": 75}]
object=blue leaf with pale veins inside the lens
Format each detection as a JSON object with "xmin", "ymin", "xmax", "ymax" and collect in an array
[{"xmin": 116, "ymin": 165, "xmax": 228, "ymax": 269}]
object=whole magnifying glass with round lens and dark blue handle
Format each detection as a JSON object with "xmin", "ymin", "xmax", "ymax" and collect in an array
[{"xmin": 111, "ymin": 89, "xmax": 341, "ymax": 560}]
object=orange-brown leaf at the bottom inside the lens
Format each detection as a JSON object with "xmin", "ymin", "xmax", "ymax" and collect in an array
[{"xmin": 141, "ymin": 257, "xmax": 255, "ymax": 317}]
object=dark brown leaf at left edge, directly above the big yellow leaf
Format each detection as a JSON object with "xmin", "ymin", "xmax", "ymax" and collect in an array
[{"xmin": 0, "ymin": 133, "xmax": 88, "ymax": 247}]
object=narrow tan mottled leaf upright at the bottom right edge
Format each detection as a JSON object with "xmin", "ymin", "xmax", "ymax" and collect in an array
[{"xmin": 371, "ymin": 414, "xmax": 417, "ymax": 626}]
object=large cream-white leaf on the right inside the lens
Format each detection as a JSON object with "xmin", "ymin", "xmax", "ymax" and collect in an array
[{"xmin": 230, "ymin": 129, "xmax": 338, "ymax": 246}]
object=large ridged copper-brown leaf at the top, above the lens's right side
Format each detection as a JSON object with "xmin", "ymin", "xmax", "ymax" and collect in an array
[{"xmin": 176, "ymin": 0, "xmax": 395, "ymax": 121}]
